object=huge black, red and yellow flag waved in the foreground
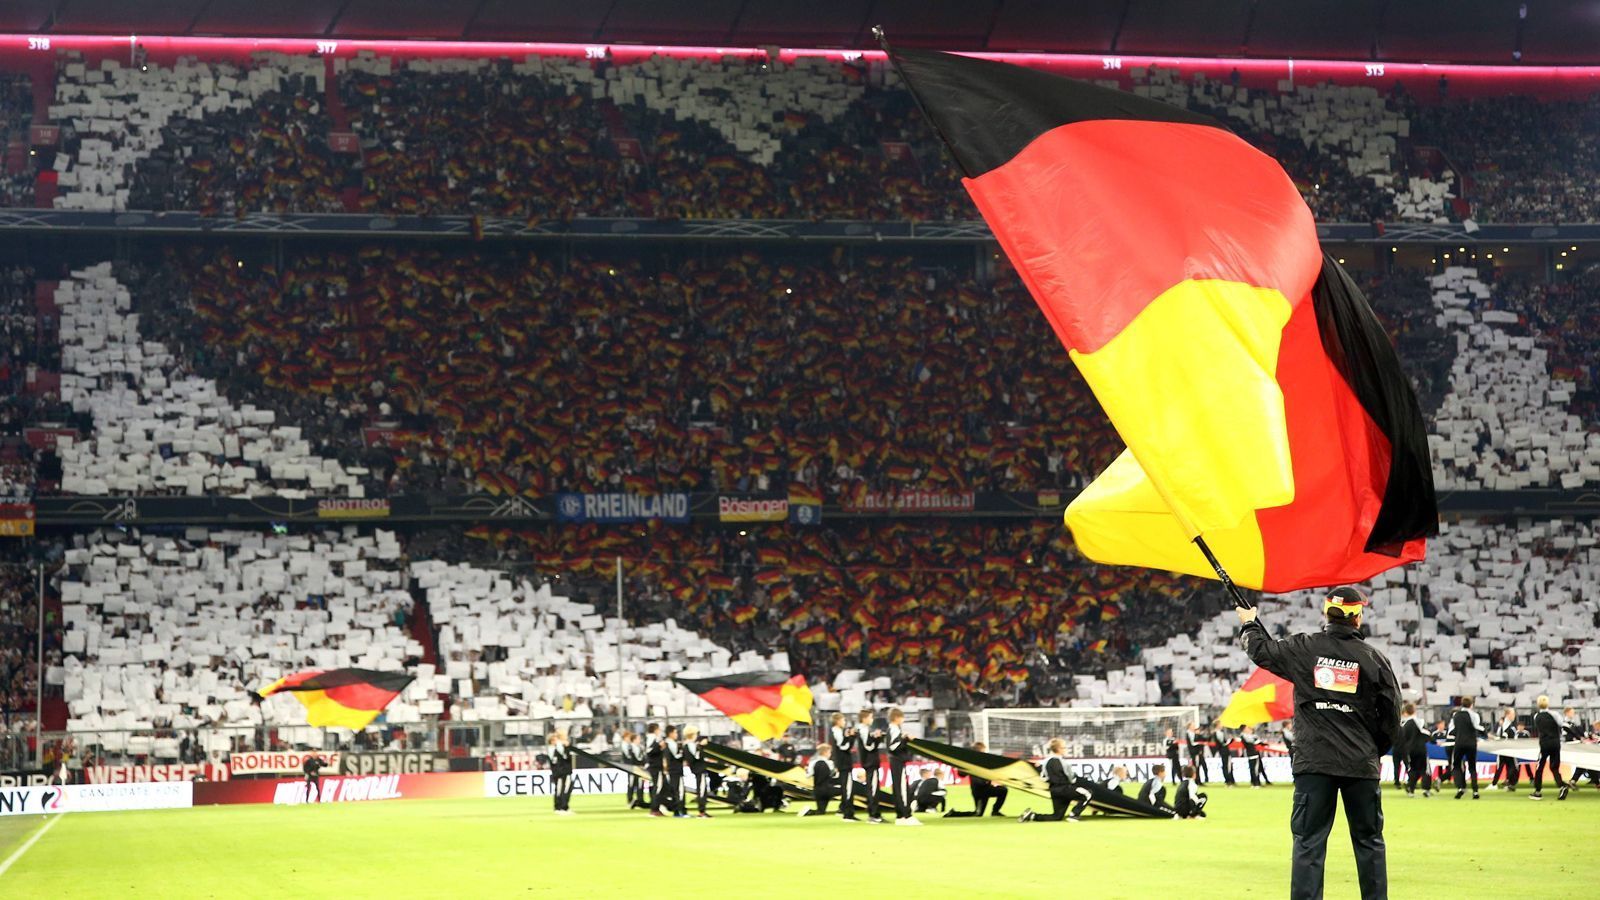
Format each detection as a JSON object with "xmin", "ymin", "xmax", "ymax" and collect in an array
[{"xmin": 891, "ymin": 43, "xmax": 1437, "ymax": 591}]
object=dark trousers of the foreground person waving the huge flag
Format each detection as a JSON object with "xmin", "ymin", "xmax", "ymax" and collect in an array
[{"xmin": 1290, "ymin": 773, "xmax": 1389, "ymax": 900}]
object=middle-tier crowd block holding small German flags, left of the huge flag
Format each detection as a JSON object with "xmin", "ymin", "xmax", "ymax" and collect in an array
[{"xmin": 147, "ymin": 245, "xmax": 1115, "ymax": 498}]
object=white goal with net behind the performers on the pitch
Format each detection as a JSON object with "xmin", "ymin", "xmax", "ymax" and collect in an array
[{"xmin": 973, "ymin": 706, "xmax": 1200, "ymax": 759}]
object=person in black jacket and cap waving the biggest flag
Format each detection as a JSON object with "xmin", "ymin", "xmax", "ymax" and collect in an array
[{"xmin": 1237, "ymin": 588, "xmax": 1400, "ymax": 900}]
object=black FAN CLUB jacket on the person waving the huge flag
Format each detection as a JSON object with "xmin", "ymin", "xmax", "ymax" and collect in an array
[{"xmin": 1238, "ymin": 620, "xmax": 1400, "ymax": 778}]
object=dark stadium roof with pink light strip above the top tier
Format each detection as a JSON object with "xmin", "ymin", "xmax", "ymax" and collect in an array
[{"xmin": 9, "ymin": 0, "xmax": 1600, "ymax": 64}]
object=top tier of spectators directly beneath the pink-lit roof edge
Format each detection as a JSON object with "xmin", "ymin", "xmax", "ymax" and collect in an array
[{"xmin": 0, "ymin": 53, "xmax": 1600, "ymax": 223}]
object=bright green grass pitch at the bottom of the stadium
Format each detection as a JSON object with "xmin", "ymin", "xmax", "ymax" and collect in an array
[{"xmin": 0, "ymin": 786, "xmax": 1600, "ymax": 900}]
